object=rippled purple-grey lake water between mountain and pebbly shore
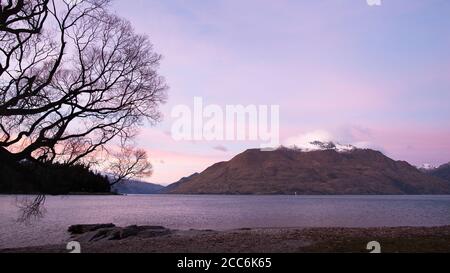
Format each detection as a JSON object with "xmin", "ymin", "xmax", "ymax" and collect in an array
[{"xmin": 0, "ymin": 195, "xmax": 450, "ymax": 248}]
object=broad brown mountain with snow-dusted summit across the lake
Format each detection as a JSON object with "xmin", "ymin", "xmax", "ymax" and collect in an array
[{"xmin": 165, "ymin": 143, "xmax": 450, "ymax": 194}]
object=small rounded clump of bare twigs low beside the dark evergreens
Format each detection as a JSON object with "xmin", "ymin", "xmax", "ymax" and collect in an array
[{"xmin": 107, "ymin": 146, "xmax": 153, "ymax": 186}]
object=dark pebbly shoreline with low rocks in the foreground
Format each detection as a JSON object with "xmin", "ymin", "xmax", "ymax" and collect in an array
[{"xmin": 0, "ymin": 225, "xmax": 450, "ymax": 253}]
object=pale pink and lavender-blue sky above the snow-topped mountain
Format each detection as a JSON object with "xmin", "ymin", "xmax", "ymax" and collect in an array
[{"xmin": 112, "ymin": 0, "xmax": 450, "ymax": 184}]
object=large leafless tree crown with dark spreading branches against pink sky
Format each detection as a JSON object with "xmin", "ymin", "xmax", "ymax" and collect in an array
[{"xmin": 0, "ymin": 0, "xmax": 167, "ymax": 164}]
